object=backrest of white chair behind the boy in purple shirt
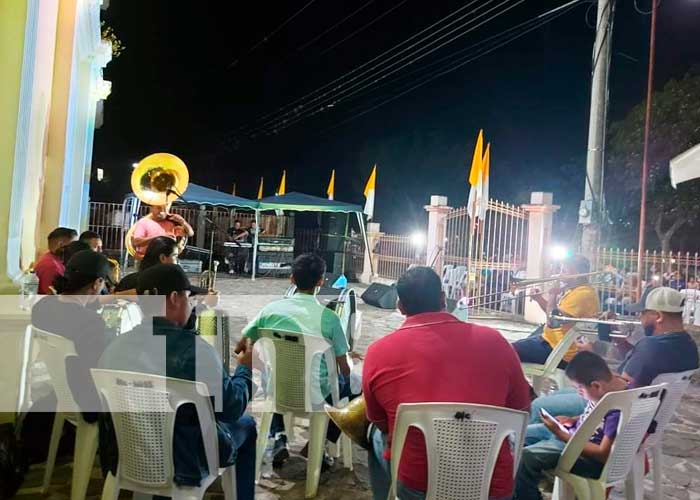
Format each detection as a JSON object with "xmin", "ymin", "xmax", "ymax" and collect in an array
[{"xmin": 558, "ymin": 384, "xmax": 666, "ymax": 485}]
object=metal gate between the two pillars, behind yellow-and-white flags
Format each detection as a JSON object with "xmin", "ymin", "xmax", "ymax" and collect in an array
[{"xmin": 443, "ymin": 200, "xmax": 528, "ymax": 314}]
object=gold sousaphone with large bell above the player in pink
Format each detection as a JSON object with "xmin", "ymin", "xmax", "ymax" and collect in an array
[{"xmin": 124, "ymin": 153, "xmax": 190, "ymax": 257}]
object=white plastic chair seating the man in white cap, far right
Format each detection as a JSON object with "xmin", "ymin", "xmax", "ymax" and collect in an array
[{"xmin": 625, "ymin": 370, "xmax": 697, "ymax": 500}]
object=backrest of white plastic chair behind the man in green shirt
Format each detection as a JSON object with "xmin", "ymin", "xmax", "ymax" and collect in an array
[{"xmin": 255, "ymin": 329, "xmax": 339, "ymax": 413}]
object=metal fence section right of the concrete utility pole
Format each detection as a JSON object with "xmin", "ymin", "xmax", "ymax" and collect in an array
[{"xmin": 590, "ymin": 248, "xmax": 700, "ymax": 312}]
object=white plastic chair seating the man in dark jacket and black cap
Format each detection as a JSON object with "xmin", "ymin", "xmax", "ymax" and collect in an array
[{"xmin": 90, "ymin": 369, "xmax": 236, "ymax": 500}]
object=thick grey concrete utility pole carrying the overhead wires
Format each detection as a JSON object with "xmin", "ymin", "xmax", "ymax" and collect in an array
[{"xmin": 579, "ymin": 0, "xmax": 614, "ymax": 256}]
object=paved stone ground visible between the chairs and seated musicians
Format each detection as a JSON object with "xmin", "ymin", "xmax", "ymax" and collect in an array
[{"xmin": 13, "ymin": 276, "xmax": 700, "ymax": 500}]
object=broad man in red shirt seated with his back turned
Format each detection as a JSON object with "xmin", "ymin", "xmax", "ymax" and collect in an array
[{"xmin": 362, "ymin": 267, "xmax": 530, "ymax": 499}]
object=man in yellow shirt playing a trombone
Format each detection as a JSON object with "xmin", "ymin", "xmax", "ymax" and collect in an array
[{"xmin": 513, "ymin": 255, "xmax": 600, "ymax": 364}]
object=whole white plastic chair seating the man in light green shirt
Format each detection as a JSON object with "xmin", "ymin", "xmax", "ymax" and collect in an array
[{"xmin": 253, "ymin": 329, "xmax": 352, "ymax": 498}]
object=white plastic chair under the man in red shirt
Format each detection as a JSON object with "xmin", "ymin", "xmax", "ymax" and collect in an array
[{"xmin": 388, "ymin": 403, "xmax": 528, "ymax": 500}]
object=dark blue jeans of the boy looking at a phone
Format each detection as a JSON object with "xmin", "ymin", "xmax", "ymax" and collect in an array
[{"xmin": 515, "ymin": 424, "xmax": 603, "ymax": 500}]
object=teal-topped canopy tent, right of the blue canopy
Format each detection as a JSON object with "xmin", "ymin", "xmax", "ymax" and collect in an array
[{"xmin": 252, "ymin": 192, "xmax": 374, "ymax": 279}]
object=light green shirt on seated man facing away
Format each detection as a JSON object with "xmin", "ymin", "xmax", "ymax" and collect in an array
[{"xmin": 243, "ymin": 292, "xmax": 349, "ymax": 357}]
